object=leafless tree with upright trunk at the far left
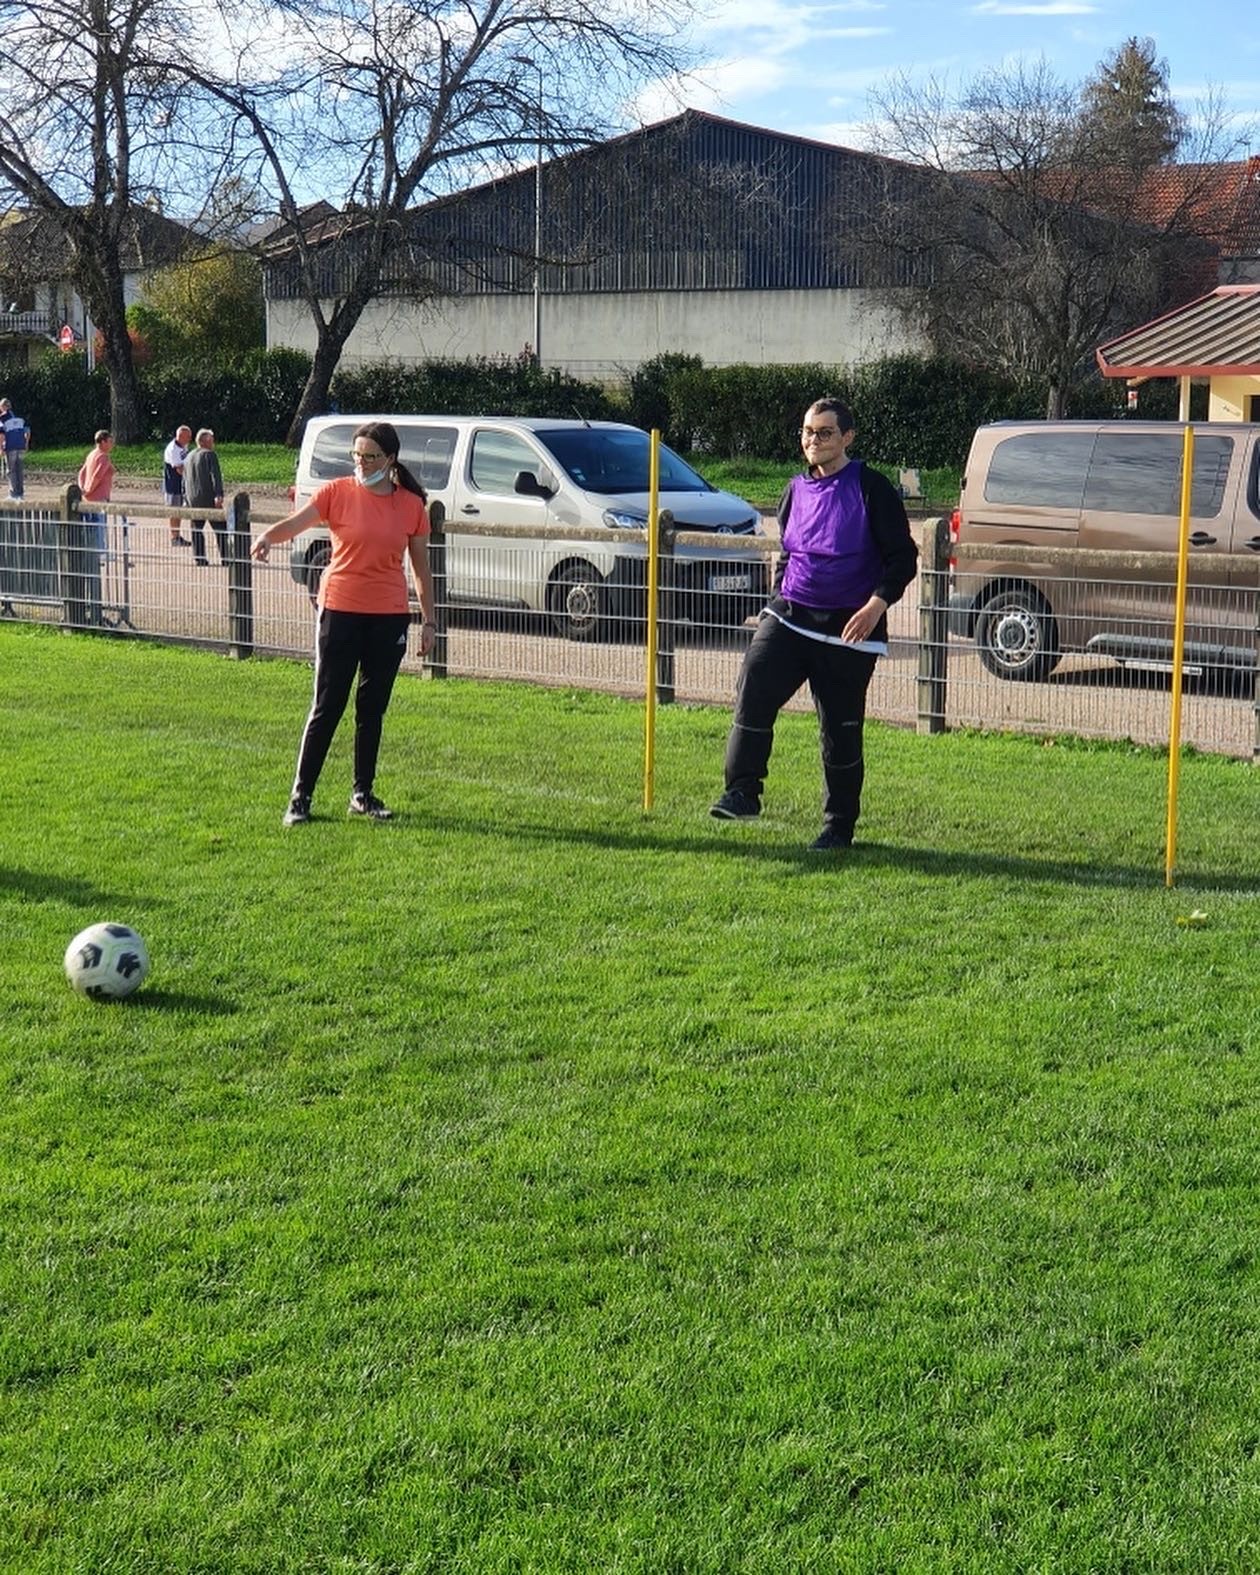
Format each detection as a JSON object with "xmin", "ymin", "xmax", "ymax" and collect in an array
[{"xmin": 0, "ymin": 0, "xmax": 207, "ymax": 441}]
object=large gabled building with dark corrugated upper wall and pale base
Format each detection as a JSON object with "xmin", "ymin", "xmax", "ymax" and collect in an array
[{"xmin": 265, "ymin": 110, "xmax": 920, "ymax": 375}]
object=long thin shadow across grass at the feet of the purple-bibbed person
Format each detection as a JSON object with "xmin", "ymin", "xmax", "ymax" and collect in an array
[{"xmin": 428, "ymin": 817, "xmax": 1260, "ymax": 891}]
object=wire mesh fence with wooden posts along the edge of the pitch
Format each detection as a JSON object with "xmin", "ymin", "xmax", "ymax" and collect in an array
[{"xmin": 0, "ymin": 488, "xmax": 1260, "ymax": 758}]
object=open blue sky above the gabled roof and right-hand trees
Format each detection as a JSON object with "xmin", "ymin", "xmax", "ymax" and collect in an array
[{"xmin": 639, "ymin": 0, "xmax": 1260, "ymax": 151}]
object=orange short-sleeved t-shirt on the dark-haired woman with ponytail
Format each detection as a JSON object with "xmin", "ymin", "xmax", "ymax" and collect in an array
[{"xmin": 310, "ymin": 476, "xmax": 428, "ymax": 613}]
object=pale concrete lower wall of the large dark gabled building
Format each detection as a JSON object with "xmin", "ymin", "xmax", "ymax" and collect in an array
[{"xmin": 266, "ymin": 290, "xmax": 926, "ymax": 380}]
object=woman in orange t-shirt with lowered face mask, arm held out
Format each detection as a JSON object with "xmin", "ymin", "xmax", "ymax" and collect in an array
[{"xmin": 252, "ymin": 421, "xmax": 436, "ymax": 825}]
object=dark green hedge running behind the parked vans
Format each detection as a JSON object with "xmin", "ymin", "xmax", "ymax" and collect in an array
[{"xmin": 0, "ymin": 350, "xmax": 1177, "ymax": 469}]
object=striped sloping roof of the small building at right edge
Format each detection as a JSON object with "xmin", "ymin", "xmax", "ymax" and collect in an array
[{"xmin": 1096, "ymin": 285, "xmax": 1260, "ymax": 378}]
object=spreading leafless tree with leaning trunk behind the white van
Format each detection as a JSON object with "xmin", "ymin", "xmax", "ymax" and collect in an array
[{"xmin": 173, "ymin": 0, "xmax": 685, "ymax": 443}]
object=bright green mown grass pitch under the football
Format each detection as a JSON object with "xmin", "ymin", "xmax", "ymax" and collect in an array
[{"xmin": 0, "ymin": 625, "xmax": 1260, "ymax": 1575}]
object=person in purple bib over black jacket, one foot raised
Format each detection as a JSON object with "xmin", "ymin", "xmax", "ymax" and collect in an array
[{"xmin": 709, "ymin": 398, "xmax": 918, "ymax": 852}]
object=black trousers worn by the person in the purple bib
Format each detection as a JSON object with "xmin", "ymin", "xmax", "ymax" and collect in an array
[{"xmin": 726, "ymin": 613, "xmax": 876, "ymax": 836}]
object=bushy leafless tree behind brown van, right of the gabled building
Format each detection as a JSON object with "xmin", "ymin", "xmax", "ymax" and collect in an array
[{"xmin": 863, "ymin": 63, "xmax": 1247, "ymax": 416}]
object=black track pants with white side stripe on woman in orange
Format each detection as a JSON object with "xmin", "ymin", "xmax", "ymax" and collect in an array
[{"xmin": 293, "ymin": 608, "xmax": 411, "ymax": 799}]
